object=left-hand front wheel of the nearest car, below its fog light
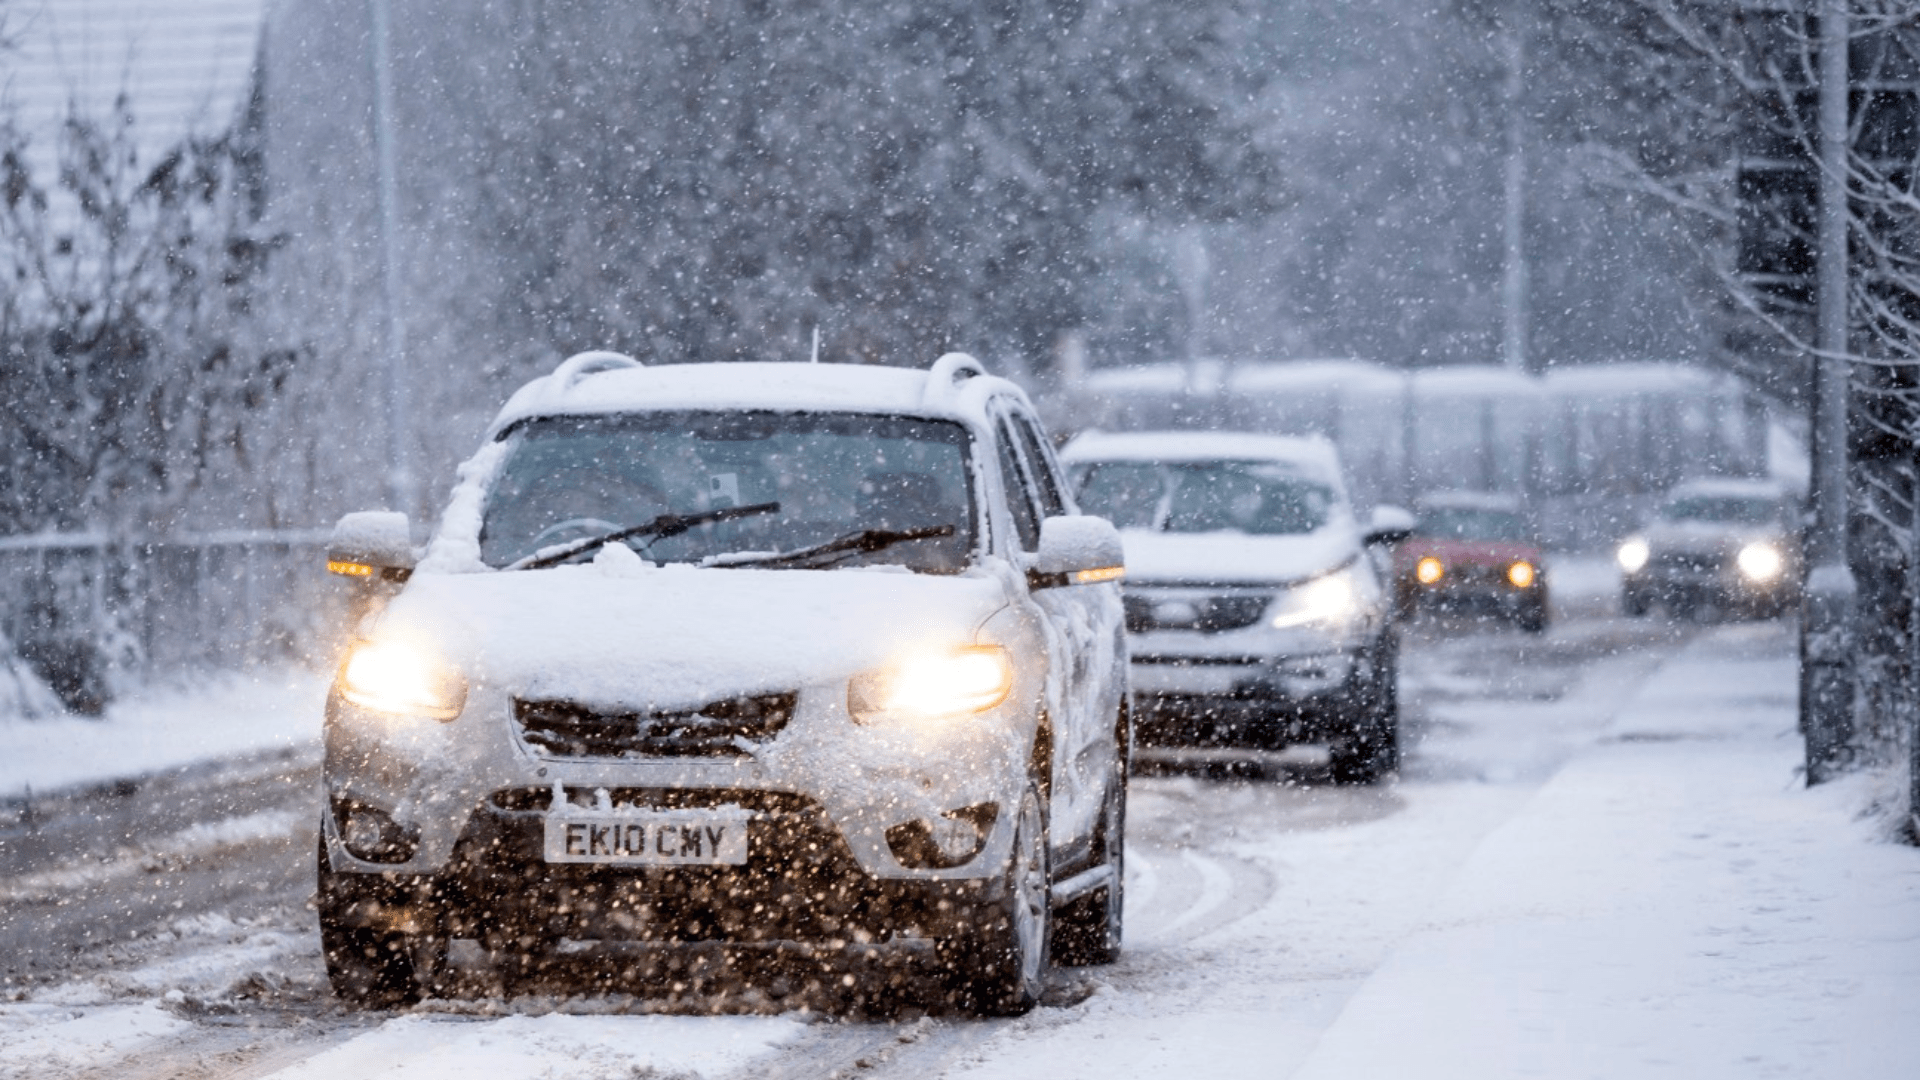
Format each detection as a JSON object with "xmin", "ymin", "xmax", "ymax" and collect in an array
[{"xmin": 317, "ymin": 836, "xmax": 447, "ymax": 1009}]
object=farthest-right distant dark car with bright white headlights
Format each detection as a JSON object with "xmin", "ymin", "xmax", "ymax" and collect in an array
[{"xmin": 1617, "ymin": 480, "xmax": 1801, "ymax": 617}]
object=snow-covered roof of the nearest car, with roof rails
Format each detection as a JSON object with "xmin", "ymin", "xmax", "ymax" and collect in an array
[{"xmin": 488, "ymin": 352, "xmax": 1025, "ymax": 438}]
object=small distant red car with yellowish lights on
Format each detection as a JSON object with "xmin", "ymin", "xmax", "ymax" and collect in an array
[{"xmin": 1394, "ymin": 492, "xmax": 1548, "ymax": 634}]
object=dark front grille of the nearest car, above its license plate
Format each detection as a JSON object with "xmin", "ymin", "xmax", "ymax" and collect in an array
[{"xmin": 513, "ymin": 692, "xmax": 799, "ymax": 757}]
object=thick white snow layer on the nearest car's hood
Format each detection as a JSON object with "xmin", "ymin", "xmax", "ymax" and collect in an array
[{"xmin": 372, "ymin": 548, "xmax": 1004, "ymax": 707}]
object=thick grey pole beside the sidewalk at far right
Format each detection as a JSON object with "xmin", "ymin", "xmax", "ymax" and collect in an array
[{"xmin": 1799, "ymin": 0, "xmax": 1855, "ymax": 784}]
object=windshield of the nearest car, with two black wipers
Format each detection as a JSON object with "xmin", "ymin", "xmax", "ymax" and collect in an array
[{"xmin": 480, "ymin": 411, "xmax": 973, "ymax": 573}]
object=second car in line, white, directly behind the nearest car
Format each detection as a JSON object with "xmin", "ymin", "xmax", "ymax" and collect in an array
[{"xmin": 1062, "ymin": 432, "xmax": 1405, "ymax": 782}]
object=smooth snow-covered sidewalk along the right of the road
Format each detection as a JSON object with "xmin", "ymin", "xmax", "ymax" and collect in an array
[{"xmin": 1296, "ymin": 626, "xmax": 1920, "ymax": 1080}]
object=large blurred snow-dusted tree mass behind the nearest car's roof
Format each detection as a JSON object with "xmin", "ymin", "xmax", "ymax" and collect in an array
[{"xmin": 255, "ymin": 0, "xmax": 1275, "ymax": 511}]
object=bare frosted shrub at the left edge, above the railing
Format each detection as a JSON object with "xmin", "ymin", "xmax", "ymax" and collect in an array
[{"xmin": 0, "ymin": 100, "xmax": 288, "ymax": 534}]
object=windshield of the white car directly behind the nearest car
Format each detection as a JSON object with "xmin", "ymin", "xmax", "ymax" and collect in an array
[{"xmin": 1079, "ymin": 461, "xmax": 1334, "ymax": 536}]
